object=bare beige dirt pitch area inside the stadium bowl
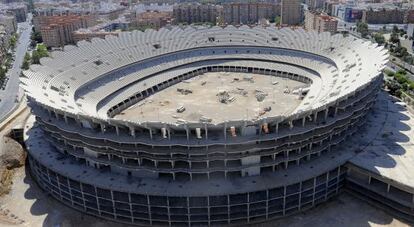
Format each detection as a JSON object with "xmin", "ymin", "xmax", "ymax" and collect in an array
[{"xmin": 115, "ymin": 72, "xmax": 306, "ymax": 123}]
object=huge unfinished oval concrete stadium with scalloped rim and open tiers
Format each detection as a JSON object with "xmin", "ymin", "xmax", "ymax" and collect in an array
[{"xmin": 21, "ymin": 26, "xmax": 388, "ymax": 226}]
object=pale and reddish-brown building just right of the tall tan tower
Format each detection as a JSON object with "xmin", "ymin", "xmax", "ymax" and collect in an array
[{"xmin": 305, "ymin": 10, "xmax": 338, "ymax": 33}]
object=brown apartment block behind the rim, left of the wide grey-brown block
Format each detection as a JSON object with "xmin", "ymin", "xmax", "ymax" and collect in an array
[{"xmin": 173, "ymin": 3, "xmax": 222, "ymax": 24}]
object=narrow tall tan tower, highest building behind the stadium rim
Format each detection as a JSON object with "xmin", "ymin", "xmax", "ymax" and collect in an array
[{"xmin": 281, "ymin": 0, "xmax": 302, "ymax": 25}]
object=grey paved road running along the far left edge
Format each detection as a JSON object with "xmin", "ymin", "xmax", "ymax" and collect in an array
[{"xmin": 0, "ymin": 15, "xmax": 32, "ymax": 120}]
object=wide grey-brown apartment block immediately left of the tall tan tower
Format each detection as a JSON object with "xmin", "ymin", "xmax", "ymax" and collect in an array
[{"xmin": 223, "ymin": 2, "xmax": 280, "ymax": 25}]
